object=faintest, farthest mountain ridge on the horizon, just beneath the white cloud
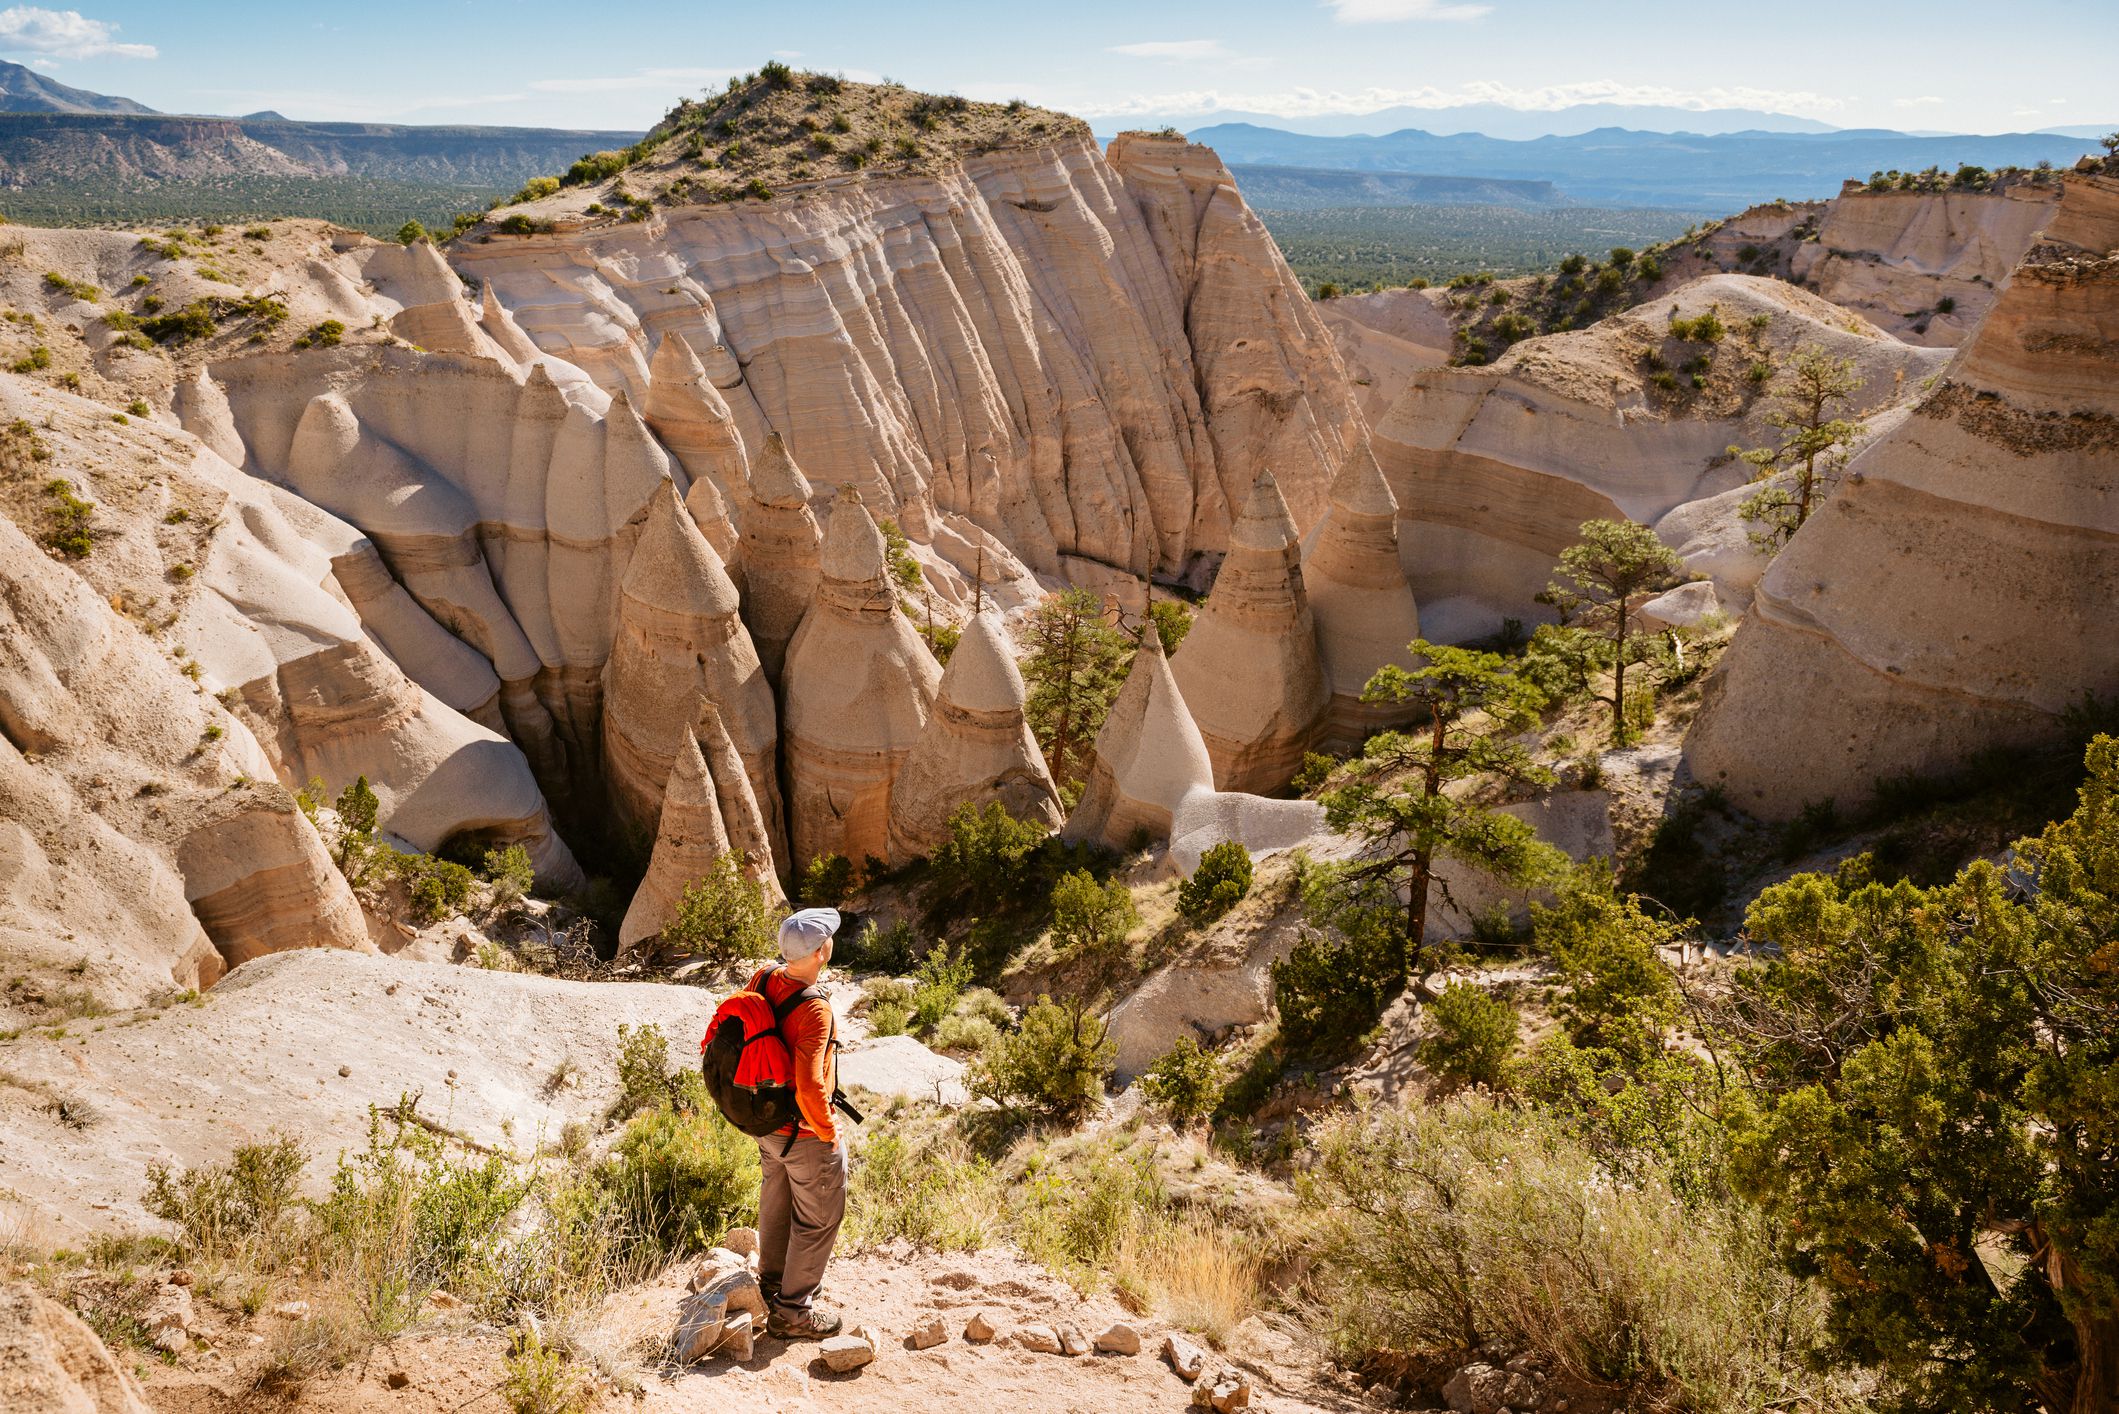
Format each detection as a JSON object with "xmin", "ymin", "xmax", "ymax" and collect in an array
[{"xmin": 1089, "ymin": 104, "xmax": 1837, "ymax": 142}]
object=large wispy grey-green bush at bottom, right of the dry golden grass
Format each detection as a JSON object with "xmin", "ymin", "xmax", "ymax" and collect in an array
[{"xmin": 1301, "ymin": 1100, "xmax": 1839, "ymax": 1414}]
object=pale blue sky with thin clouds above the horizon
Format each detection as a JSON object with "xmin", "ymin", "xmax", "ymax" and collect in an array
[{"xmin": 0, "ymin": 0, "xmax": 2119, "ymax": 131}]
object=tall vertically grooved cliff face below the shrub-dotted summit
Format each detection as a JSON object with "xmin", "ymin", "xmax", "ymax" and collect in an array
[{"xmin": 458, "ymin": 136, "xmax": 1365, "ymax": 585}]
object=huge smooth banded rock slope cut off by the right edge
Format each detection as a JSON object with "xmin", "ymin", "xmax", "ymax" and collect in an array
[{"xmin": 1685, "ymin": 174, "xmax": 2119, "ymax": 816}]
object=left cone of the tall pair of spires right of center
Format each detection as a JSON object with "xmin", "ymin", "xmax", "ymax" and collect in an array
[{"xmin": 1172, "ymin": 471, "xmax": 1331, "ymax": 795}]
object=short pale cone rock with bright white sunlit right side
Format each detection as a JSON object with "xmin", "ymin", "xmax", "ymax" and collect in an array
[{"xmin": 1060, "ymin": 628, "xmax": 1214, "ymax": 850}]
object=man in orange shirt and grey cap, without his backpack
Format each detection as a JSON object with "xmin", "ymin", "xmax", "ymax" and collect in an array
[{"xmin": 750, "ymin": 907, "xmax": 845, "ymax": 1340}]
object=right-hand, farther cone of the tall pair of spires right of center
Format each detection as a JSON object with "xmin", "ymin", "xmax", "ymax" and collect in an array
[{"xmin": 1303, "ymin": 454, "xmax": 1420, "ymax": 750}]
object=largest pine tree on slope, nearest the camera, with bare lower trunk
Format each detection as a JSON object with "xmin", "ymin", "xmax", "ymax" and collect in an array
[{"xmin": 1322, "ymin": 638, "xmax": 1560, "ymax": 977}]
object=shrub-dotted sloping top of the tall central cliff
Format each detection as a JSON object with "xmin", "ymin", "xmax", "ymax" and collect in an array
[{"xmin": 474, "ymin": 61, "xmax": 1089, "ymax": 233}]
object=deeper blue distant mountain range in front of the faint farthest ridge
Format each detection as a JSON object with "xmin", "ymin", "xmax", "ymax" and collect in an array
[{"xmin": 1189, "ymin": 123, "xmax": 2098, "ymax": 210}]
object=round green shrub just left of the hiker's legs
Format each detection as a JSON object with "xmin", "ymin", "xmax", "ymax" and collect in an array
[{"xmin": 604, "ymin": 1102, "xmax": 759, "ymax": 1257}]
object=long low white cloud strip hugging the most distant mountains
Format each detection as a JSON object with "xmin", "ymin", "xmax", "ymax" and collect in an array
[{"xmin": 1070, "ymin": 78, "xmax": 1846, "ymax": 119}]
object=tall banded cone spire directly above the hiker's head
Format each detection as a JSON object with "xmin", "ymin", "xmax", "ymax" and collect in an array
[{"xmin": 780, "ymin": 488, "xmax": 941, "ymax": 869}]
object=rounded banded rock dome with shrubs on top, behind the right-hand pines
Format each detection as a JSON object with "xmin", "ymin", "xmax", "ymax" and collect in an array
[{"xmin": 1373, "ymin": 276, "xmax": 1947, "ymax": 642}]
